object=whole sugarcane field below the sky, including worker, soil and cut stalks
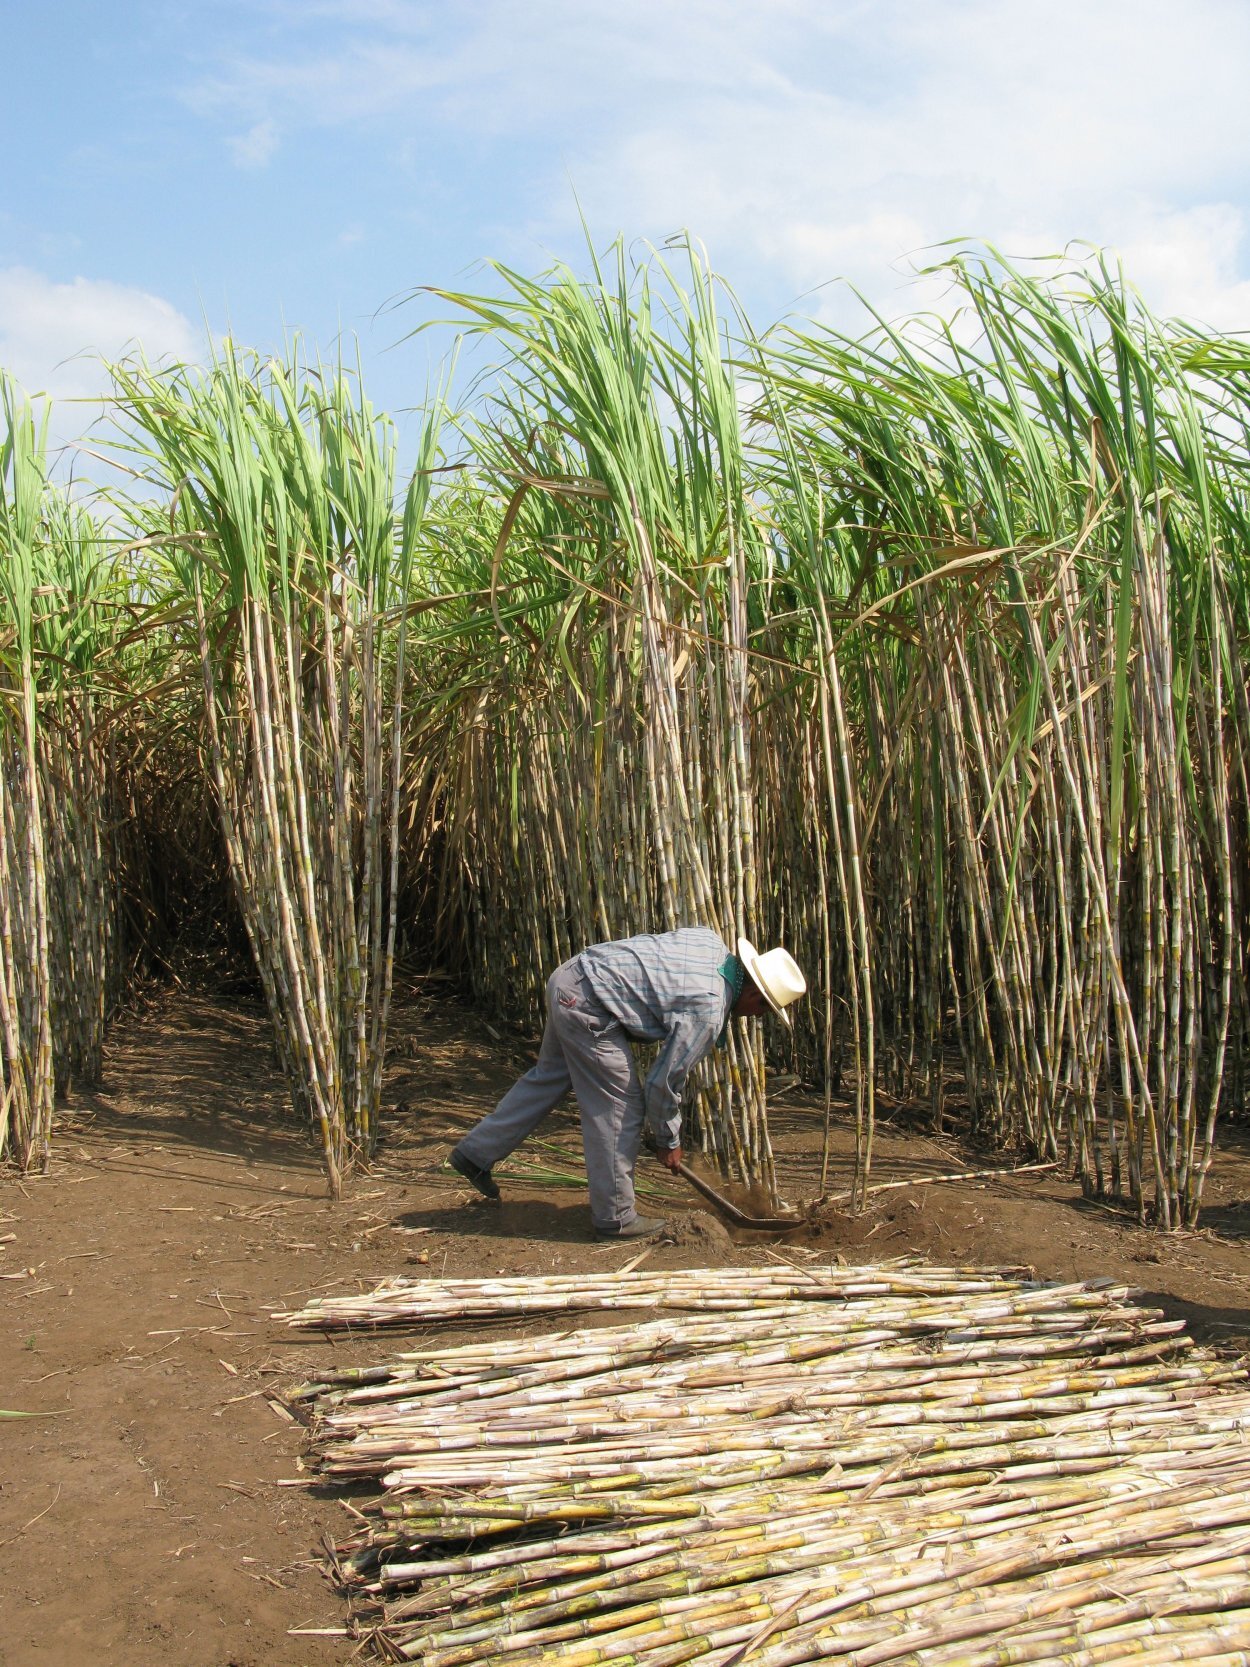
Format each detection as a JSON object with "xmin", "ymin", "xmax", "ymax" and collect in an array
[{"xmin": 0, "ymin": 237, "xmax": 1250, "ymax": 1667}]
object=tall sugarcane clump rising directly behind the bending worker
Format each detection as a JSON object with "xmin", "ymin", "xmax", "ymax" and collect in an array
[{"xmin": 416, "ymin": 250, "xmax": 773, "ymax": 1187}]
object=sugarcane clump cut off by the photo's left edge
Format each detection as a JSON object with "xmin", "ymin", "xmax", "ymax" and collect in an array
[{"xmin": 0, "ymin": 375, "xmax": 117, "ymax": 1169}]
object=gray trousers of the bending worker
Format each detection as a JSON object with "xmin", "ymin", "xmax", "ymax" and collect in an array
[{"xmin": 457, "ymin": 957, "xmax": 643, "ymax": 1232}]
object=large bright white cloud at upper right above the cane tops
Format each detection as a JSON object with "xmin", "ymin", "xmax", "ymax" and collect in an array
[{"xmin": 552, "ymin": 0, "xmax": 1250, "ymax": 325}]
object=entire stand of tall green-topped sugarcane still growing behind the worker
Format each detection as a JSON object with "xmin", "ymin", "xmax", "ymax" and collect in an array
[{"xmin": 0, "ymin": 247, "xmax": 1250, "ymax": 1229}]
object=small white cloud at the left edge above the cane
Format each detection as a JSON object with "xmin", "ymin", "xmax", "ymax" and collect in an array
[{"xmin": 0, "ymin": 267, "xmax": 203, "ymax": 410}]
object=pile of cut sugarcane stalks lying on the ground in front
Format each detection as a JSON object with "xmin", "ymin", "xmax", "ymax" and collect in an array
[{"xmin": 287, "ymin": 1264, "xmax": 1250, "ymax": 1667}]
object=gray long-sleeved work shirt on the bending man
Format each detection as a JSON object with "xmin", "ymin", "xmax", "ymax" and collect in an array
[{"xmin": 577, "ymin": 927, "xmax": 733, "ymax": 1150}]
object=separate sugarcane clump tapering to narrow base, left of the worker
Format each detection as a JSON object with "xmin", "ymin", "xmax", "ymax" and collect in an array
[{"xmin": 115, "ymin": 347, "xmax": 437, "ymax": 1197}]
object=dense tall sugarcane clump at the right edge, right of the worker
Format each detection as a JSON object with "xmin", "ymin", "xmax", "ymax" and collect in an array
[{"xmin": 757, "ymin": 246, "xmax": 1245, "ymax": 1225}]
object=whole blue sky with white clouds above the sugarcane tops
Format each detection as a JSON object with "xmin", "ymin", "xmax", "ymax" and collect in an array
[{"xmin": 0, "ymin": 0, "xmax": 1250, "ymax": 460}]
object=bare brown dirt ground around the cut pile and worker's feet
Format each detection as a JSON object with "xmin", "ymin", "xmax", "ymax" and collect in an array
[{"xmin": 0, "ymin": 987, "xmax": 1250, "ymax": 1667}]
